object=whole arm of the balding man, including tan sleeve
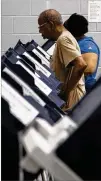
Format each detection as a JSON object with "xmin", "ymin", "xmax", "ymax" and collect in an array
[{"xmin": 58, "ymin": 37, "xmax": 87, "ymax": 93}]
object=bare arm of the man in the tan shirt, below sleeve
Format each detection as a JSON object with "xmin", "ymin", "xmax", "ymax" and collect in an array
[{"xmin": 67, "ymin": 56, "xmax": 87, "ymax": 94}]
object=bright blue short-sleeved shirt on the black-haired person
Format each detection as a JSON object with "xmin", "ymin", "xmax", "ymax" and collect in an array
[{"xmin": 78, "ymin": 36, "xmax": 100, "ymax": 90}]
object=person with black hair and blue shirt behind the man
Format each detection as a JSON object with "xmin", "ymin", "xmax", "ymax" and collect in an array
[{"xmin": 64, "ymin": 13, "xmax": 100, "ymax": 92}]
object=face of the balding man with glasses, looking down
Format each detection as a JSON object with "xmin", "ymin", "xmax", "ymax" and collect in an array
[{"xmin": 38, "ymin": 18, "xmax": 53, "ymax": 39}]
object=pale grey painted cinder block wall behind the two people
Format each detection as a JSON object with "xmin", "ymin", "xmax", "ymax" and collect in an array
[{"xmin": 1, "ymin": 0, "xmax": 101, "ymax": 77}]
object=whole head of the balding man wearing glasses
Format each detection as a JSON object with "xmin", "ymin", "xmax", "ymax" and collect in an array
[{"xmin": 38, "ymin": 9, "xmax": 64, "ymax": 40}]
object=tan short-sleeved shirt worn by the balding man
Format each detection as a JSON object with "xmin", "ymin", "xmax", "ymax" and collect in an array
[{"xmin": 50, "ymin": 31, "xmax": 85, "ymax": 111}]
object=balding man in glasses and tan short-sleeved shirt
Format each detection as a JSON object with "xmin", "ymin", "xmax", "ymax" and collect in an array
[{"xmin": 38, "ymin": 9, "xmax": 87, "ymax": 111}]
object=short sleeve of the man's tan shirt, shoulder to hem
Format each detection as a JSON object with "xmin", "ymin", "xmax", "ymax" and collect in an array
[{"xmin": 57, "ymin": 37, "xmax": 81, "ymax": 67}]
